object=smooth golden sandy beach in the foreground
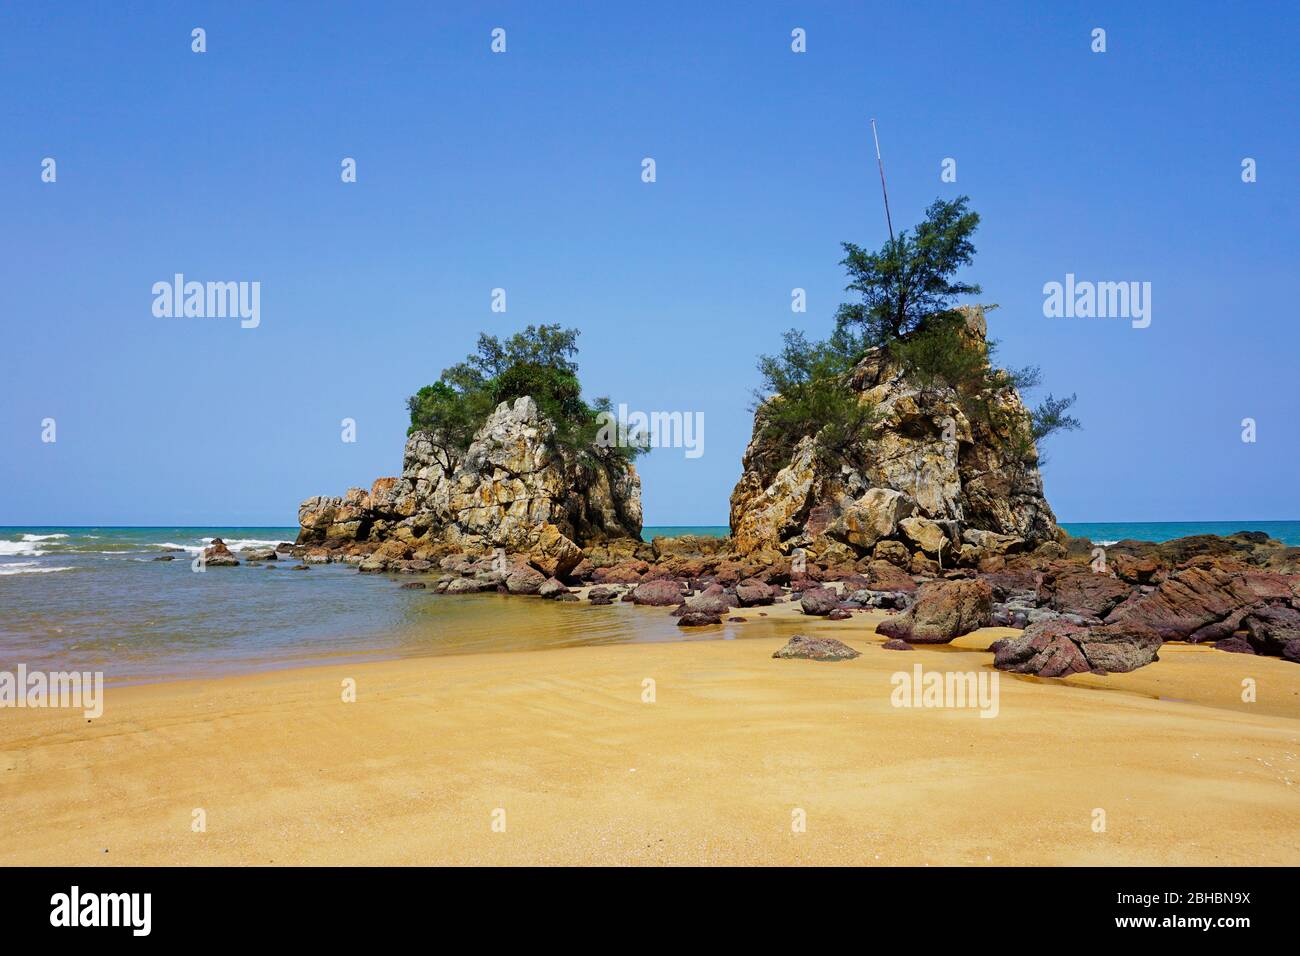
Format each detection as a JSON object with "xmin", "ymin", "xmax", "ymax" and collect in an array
[{"xmin": 0, "ymin": 607, "xmax": 1300, "ymax": 866}]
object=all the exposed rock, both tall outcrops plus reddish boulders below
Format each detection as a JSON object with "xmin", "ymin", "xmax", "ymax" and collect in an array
[{"xmin": 253, "ymin": 307, "xmax": 1300, "ymax": 676}]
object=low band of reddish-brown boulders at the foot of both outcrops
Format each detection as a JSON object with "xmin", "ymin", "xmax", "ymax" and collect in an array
[{"xmin": 205, "ymin": 532, "xmax": 1300, "ymax": 678}]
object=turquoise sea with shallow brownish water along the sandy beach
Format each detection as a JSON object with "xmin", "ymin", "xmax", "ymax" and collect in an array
[{"xmin": 0, "ymin": 522, "xmax": 1300, "ymax": 682}]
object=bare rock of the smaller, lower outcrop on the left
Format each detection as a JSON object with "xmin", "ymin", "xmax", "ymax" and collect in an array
[{"xmin": 298, "ymin": 397, "xmax": 641, "ymax": 576}]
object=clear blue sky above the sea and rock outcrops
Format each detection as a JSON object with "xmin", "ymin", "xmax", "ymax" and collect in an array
[{"xmin": 0, "ymin": 1, "xmax": 1300, "ymax": 524}]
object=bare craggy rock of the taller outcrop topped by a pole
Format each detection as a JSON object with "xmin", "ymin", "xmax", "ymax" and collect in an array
[{"xmin": 731, "ymin": 308, "xmax": 1058, "ymax": 567}]
